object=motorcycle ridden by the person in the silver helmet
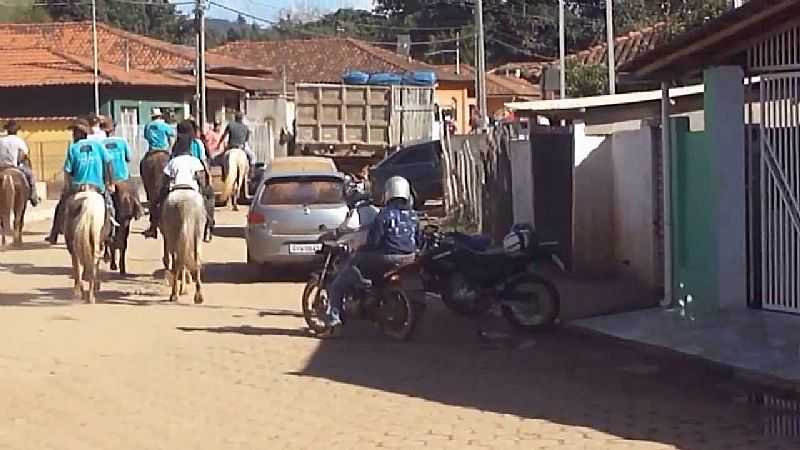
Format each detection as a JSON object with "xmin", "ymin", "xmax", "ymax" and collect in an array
[{"xmin": 302, "ymin": 195, "xmax": 423, "ymax": 340}]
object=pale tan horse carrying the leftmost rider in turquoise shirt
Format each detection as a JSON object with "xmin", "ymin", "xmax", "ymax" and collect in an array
[{"xmin": 64, "ymin": 190, "xmax": 108, "ymax": 304}]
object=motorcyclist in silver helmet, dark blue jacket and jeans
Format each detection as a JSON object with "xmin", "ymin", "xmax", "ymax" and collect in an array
[{"xmin": 328, "ymin": 177, "xmax": 418, "ymax": 330}]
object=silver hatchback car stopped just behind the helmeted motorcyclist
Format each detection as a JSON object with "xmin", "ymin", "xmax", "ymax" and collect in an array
[{"xmin": 246, "ymin": 170, "xmax": 348, "ymax": 266}]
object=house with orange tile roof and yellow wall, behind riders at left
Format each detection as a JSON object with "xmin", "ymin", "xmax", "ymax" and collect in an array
[{"xmin": 0, "ymin": 22, "xmax": 270, "ymax": 180}]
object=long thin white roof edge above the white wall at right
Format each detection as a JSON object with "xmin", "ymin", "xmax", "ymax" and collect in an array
[{"xmin": 506, "ymin": 76, "xmax": 761, "ymax": 111}]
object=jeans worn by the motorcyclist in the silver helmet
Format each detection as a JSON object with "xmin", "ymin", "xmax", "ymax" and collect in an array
[{"xmin": 327, "ymin": 250, "xmax": 414, "ymax": 320}]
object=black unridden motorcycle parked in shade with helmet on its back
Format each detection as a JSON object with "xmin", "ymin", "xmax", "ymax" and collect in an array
[{"xmin": 418, "ymin": 225, "xmax": 561, "ymax": 331}]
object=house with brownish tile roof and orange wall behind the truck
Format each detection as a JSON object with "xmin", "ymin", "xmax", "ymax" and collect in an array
[{"xmin": 210, "ymin": 37, "xmax": 475, "ymax": 132}]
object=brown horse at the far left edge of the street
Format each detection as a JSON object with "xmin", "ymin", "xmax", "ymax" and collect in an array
[{"xmin": 0, "ymin": 167, "xmax": 31, "ymax": 247}]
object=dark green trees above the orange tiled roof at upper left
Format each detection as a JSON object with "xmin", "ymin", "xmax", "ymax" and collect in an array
[{"xmin": 46, "ymin": 0, "xmax": 194, "ymax": 43}]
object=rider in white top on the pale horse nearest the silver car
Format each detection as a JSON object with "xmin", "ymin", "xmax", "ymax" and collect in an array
[{"xmin": 145, "ymin": 120, "xmax": 213, "ymax": 237}]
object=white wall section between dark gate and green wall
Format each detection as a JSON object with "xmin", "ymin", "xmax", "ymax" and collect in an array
[{"xmin": 574, "ymin": 127, "xmax": 659, "ymax": 294}]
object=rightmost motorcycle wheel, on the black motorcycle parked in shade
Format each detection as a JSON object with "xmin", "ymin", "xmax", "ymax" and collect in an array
[{"xmin": 499, "ymin": 274, "xmax": 561, "ymax": 331}]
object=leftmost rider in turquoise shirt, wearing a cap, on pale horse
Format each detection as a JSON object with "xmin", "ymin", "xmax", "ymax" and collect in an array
[{"xmin": 45, "ymin": 119, "xmax": 117, "ymax": 244}]
